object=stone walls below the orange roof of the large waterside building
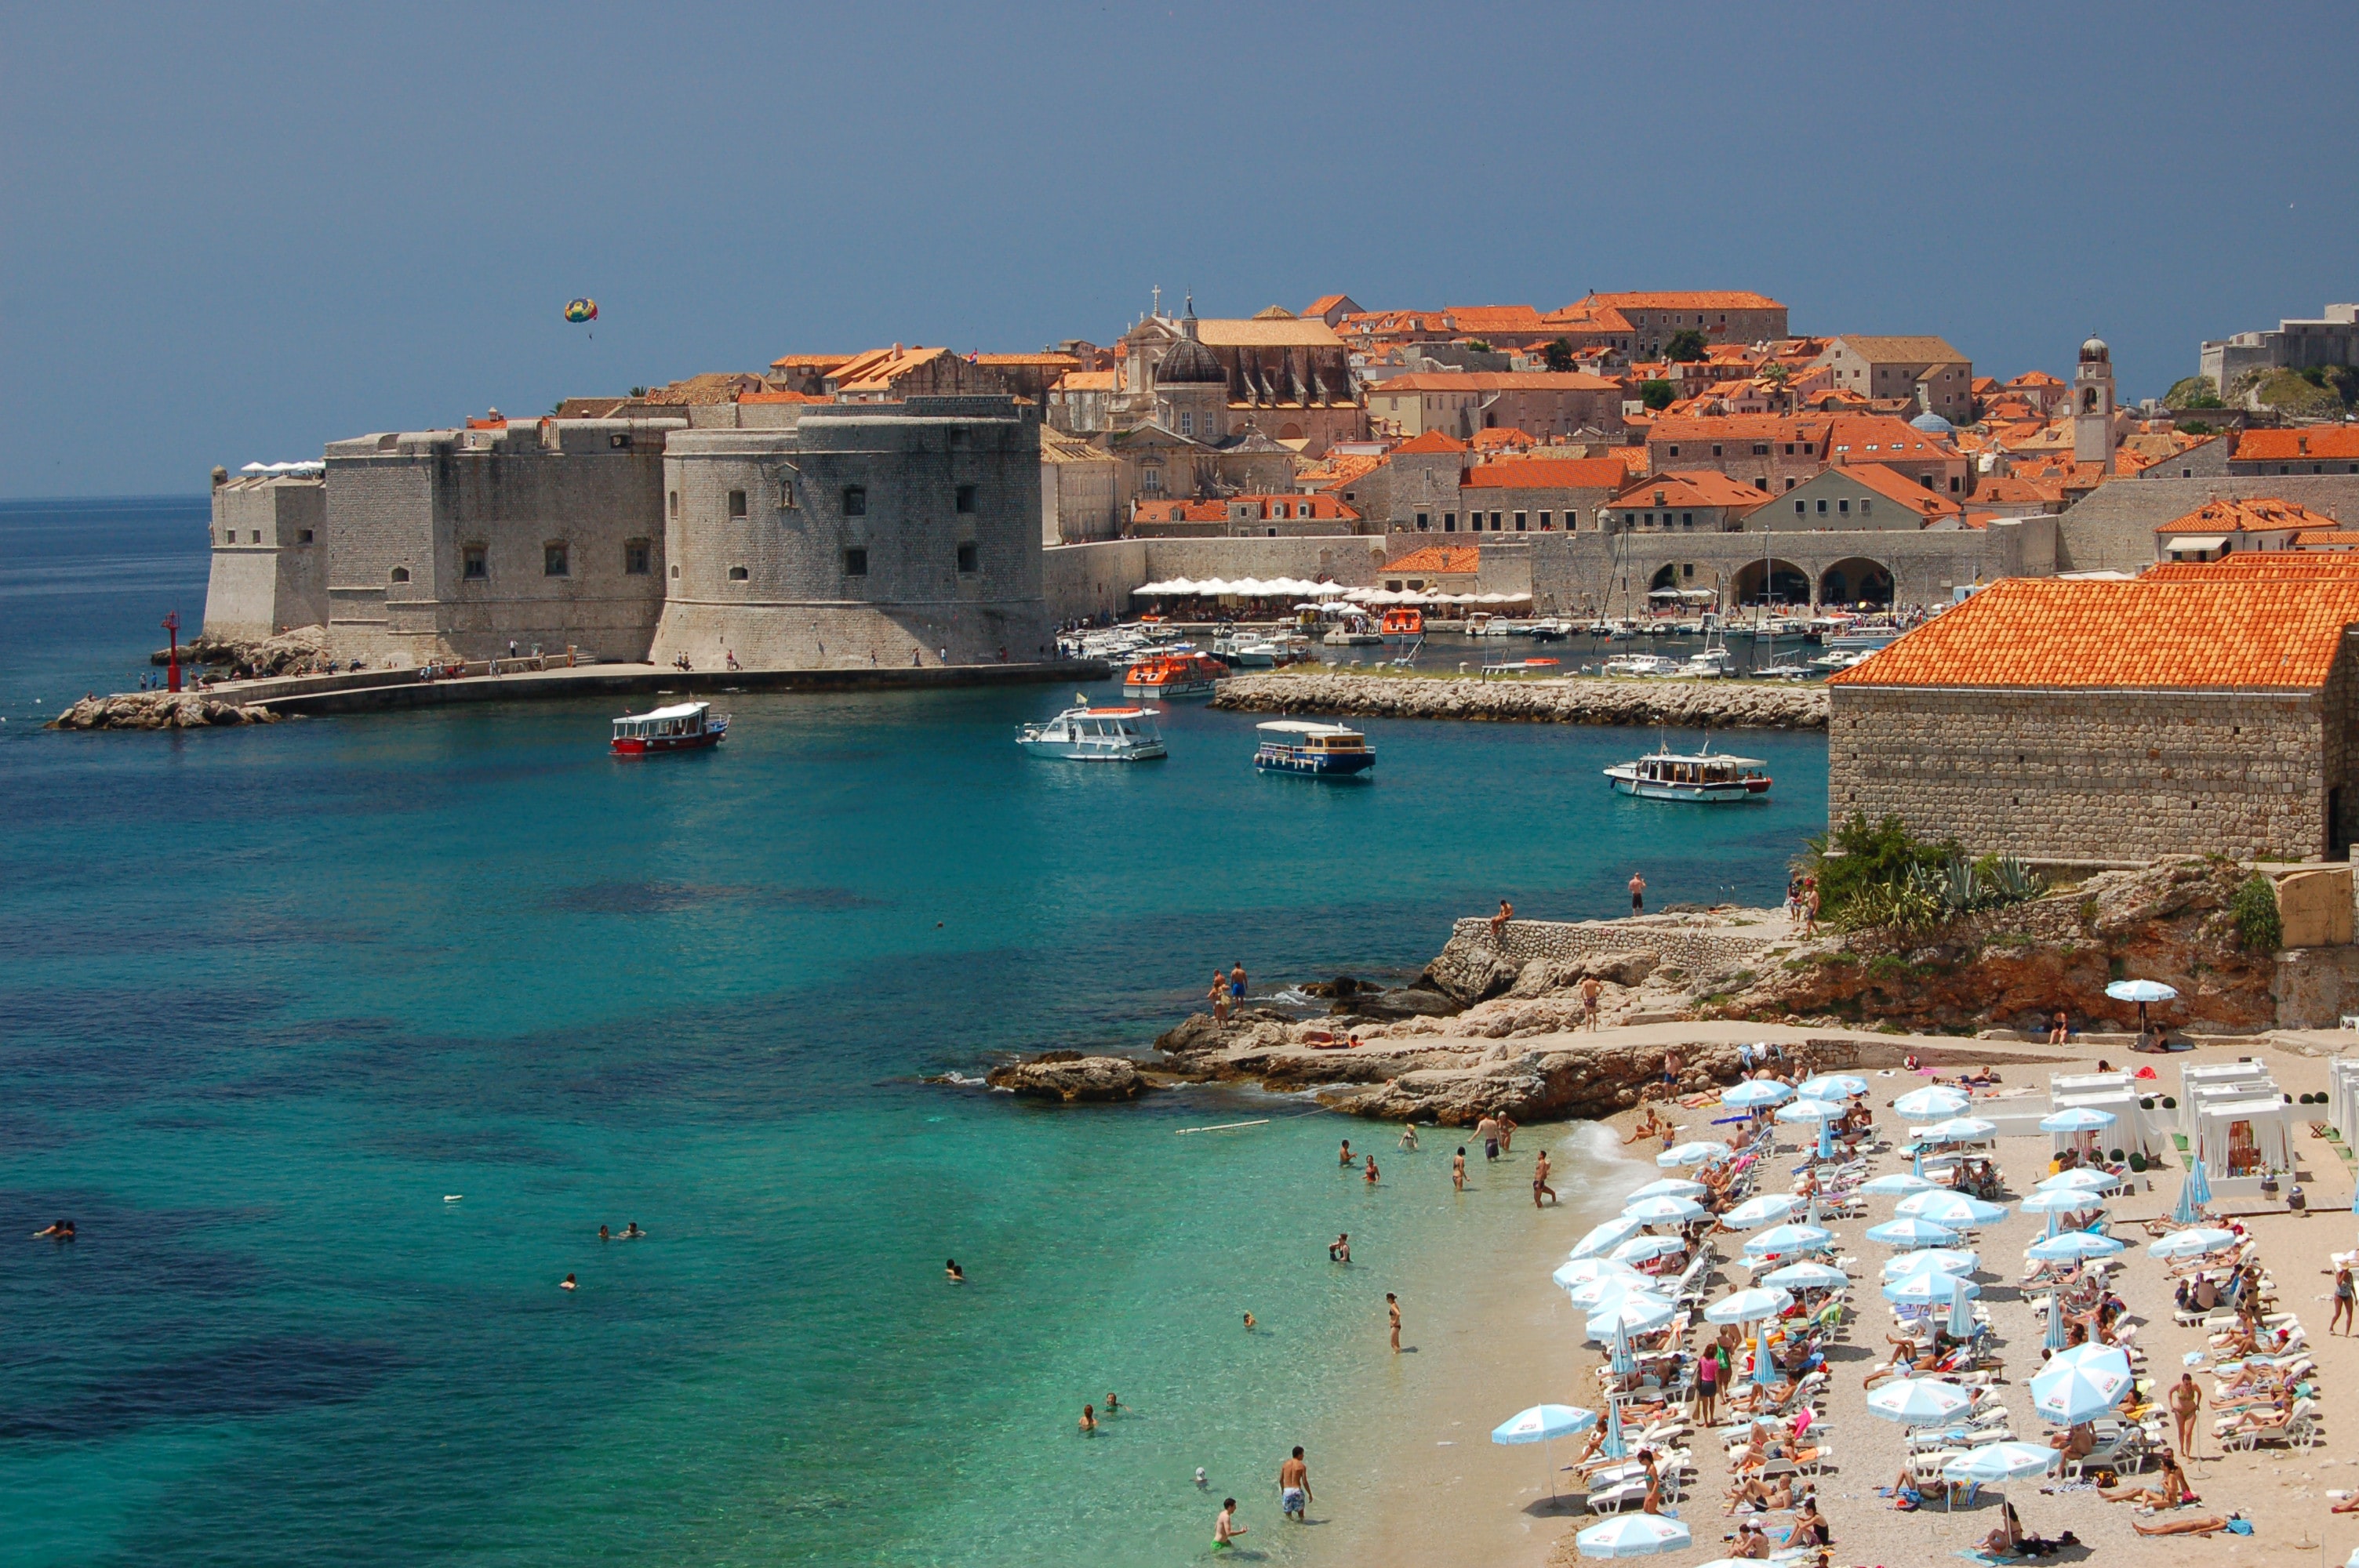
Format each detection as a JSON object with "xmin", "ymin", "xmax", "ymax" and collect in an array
[{"xmin": 1826, "ymin": 684, "xmax": 2354, "ymax": 863}]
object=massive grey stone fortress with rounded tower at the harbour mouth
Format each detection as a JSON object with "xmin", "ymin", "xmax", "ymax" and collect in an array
[{"xmin": 205, "ymin": 396, "xmax": 1052, "ymax": 670}]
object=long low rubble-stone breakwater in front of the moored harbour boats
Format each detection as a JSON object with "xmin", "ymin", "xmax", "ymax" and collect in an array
[{"xmin": 1212, "ymin": 670, "xmax": 1826, "ymax": 728}]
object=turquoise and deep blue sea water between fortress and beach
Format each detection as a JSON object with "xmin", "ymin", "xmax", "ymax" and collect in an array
[{"xmin": 0, "ymin": 503, "xmax": 1826, "ymax": 1566}]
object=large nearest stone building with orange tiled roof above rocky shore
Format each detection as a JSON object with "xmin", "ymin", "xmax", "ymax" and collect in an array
[{"xmin": 1826, "ymin": 575, "xmax": 2359, "ymax": 863}]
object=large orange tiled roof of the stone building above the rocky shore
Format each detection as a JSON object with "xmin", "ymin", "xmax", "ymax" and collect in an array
[{"xmin": 1828, "ymin": 557, "xmax": 2359, "ymax": 691}]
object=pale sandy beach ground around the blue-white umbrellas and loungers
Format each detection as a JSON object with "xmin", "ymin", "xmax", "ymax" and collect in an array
[{"xmin": 1314, "ymin": 1030, "xmax": 2359, "ymax": 1568}]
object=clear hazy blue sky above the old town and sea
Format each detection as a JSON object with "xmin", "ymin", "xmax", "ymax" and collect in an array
[{"xmin": 0, "ymin": 0, "xmax": 2359, "ymax": 498}]
